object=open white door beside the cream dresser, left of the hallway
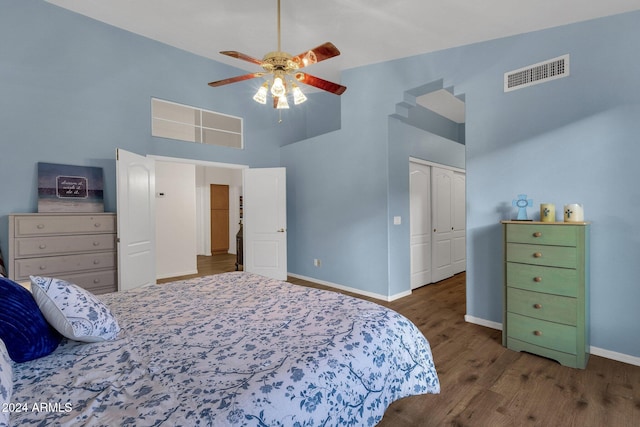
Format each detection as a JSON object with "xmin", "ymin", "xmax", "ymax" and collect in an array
[{"xmin": 116, "ymin": 149, "xmax": 156, "ymax": 291}]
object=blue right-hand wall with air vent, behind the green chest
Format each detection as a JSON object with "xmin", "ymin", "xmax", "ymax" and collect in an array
[{"xmin": 282, "ymin": 12, "xmax": 640, "ymax": 357}]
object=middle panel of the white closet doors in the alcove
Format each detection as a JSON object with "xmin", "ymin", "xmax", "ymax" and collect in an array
[{"xmin": 431, "ymin": 167, "xmax": 453, "ymax": 282}]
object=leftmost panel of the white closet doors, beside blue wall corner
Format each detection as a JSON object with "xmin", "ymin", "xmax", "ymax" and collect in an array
[{"xmin": 409, "ymin": 162, "xmax": 431, "ymax": 289}]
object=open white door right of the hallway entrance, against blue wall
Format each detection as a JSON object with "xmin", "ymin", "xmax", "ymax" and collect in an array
[{"xmin": 243, "ymin": 168, "xmax": 287, "ymax": 280}]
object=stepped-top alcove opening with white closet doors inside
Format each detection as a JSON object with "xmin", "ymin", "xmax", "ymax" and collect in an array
[{"xmin": 394, "ymin": 80, "xmax": 466, "ymax": 289}]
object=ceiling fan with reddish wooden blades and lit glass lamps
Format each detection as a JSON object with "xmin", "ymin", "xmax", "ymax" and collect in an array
[{"xmin": 209, "ymin": 0, "xmax": 347, "ymax": 109}]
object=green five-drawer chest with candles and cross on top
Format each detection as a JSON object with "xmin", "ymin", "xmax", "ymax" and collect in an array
[{"xmin": 502, "ymin": 221, "xmax": 590, "ymax": 368}]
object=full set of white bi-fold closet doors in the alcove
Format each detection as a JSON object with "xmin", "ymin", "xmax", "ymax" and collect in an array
[{"xmin": 409, "ymin": 161, "xmax": 466, "ymax": 289}]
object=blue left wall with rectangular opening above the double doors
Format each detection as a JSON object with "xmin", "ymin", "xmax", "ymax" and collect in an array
[{"xmin": 0, "ymin": 0, "xmax": 340, "ymax": 255}]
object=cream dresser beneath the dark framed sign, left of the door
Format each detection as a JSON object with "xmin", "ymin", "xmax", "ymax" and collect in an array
[{"xmin": 7, "ymin": 213, "xmax": 118, "ymax": 294}]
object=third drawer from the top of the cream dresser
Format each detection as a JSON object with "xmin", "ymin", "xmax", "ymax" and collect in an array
[{"xmin": 14, "ymin": 252, "xmax": 116, "ymax": 280}]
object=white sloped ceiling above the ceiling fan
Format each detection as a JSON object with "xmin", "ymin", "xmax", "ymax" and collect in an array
[{"xmin": 47, "ymin": 0, "xmax": 640, "ymax": 122}]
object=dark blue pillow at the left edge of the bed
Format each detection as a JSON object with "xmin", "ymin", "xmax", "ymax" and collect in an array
[{"xmin": 0, "ymin": 277, "xmax": 62, "ymax": 363}]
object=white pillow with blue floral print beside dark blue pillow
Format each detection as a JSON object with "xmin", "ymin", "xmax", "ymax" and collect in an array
[{"xmin": 31, "ymin": 276, "xmax": 120, "ymax": 342}]
